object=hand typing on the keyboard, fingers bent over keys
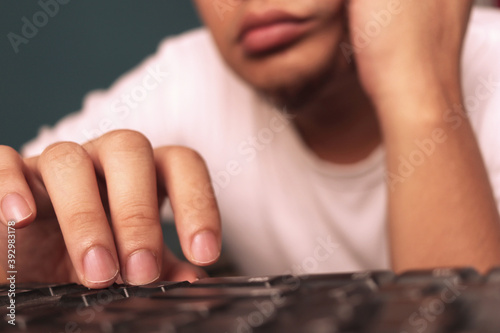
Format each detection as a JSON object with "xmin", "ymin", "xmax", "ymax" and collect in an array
[{"xmin": 0, "ymin": 130, "xmax": 221, "ymax": 288}]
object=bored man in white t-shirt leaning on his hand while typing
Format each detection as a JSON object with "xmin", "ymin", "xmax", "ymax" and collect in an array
[{"xmin": 0, "ymin": 0, "xmax": 500, "ymax": 288}]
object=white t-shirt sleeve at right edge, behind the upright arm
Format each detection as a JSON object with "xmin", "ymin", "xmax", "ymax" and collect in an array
[{"xmin": 462, "ymin": 8, "xmax": 500, "ymax": 211}]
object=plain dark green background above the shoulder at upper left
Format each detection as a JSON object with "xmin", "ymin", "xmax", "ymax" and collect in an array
[{"xmin": 0, "ymin": 0, "xmax": 200, "ymax": 149}]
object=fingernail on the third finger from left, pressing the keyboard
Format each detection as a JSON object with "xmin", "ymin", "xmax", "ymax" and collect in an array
[{"xmin": 125, "ymin": 250, "xmax": 160, "ymax": 285}]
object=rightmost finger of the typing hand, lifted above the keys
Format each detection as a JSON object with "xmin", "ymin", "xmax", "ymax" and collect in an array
[{"xmin": 155, "ymin": 147, "xmax": 221, "ymax": 265}]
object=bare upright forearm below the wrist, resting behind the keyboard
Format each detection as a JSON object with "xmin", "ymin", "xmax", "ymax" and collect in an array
[{"xmin": 381, "ymin": 87, "xmax": 500, "ymax": 271}]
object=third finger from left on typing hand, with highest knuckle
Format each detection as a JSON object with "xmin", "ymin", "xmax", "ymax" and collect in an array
[{"xmin": 85, "ymin": 131, "xmax": 163, "ymax": 285}]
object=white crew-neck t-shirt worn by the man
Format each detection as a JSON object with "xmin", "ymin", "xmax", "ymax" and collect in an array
[{"xmin": 23, "ymin": 9, "xmax": 500, "ymax": 275}]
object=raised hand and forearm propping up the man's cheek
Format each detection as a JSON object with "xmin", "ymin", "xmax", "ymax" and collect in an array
[{"xmin": 348, "ymin": 0, "xmax": 500, "ymax": 271}]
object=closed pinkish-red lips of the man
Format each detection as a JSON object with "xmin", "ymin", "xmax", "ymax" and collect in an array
[{"xmin": 238, "ymin": 10, "xmax": 310, "ymax": 55}]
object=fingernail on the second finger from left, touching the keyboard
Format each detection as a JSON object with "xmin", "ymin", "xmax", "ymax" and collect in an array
[{"xmin": 83, "ymin": 246, "xmax": 118, "ymax": 283}]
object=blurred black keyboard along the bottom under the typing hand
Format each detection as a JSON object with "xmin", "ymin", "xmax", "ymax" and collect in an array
[{"xmin": 0, "ymin": 268, "xmax": 500, "ymax": 333}]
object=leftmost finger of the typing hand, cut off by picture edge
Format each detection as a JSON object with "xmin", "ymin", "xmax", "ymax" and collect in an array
[{"xmin": 0, "ymin": 146, "xmax": 36, "ymax": 228}]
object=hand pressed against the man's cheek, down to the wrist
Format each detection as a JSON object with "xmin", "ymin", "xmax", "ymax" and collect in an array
[{"xmin": 348, "ymin": 0, "xmax": 472, "ymax": 106}]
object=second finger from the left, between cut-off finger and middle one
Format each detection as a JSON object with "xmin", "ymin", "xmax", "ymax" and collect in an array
[{"xmin": 38, "ymin": 142, "xmax": 119, "ymax": 288}]
